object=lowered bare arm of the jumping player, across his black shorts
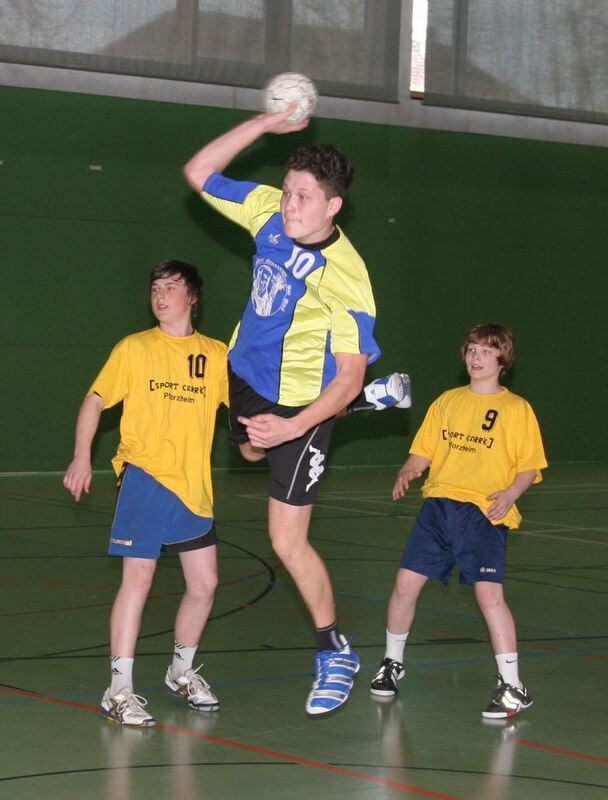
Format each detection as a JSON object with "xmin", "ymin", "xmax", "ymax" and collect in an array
[{"xmin": 239, "ymin": 353, "xmax": 367, "ymax": 449}]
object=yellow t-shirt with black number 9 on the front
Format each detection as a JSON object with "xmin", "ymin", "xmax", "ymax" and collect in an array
[{"xmin": 410, "ymin": 386, "xmax": 547, "ymax": 528}]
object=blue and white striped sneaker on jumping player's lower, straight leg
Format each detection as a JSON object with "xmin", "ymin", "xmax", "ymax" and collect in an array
[{"xmin": 306, "ymin": 636, "xmax": 359, "ymax": 717}]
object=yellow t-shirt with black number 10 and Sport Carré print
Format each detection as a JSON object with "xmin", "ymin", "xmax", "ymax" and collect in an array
[{"xmin": 87, "ymin": 327, "xmax": 228, "ymax": 517}]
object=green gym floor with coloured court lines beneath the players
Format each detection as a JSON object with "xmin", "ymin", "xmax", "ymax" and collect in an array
[{"xmin": 0, "ymin": 465, "xmax": 608, "ymax": 800}]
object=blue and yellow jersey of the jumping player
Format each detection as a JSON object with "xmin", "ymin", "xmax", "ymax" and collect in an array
[{"xmin": 201, "ymin": 173, "xmax": 380, "ymax": 406}]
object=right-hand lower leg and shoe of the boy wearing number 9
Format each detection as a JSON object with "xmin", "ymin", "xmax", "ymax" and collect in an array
[{"xmin": 474, "ymin": 581, "xmax": 533, "ymax": 719}]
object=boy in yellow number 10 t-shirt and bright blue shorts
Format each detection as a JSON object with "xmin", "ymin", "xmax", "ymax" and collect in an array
[{"xmin": 63, "ymin": 260, "xmax": 228, "ymax": 728}]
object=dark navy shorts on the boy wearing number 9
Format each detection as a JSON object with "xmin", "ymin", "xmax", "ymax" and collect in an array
[{"xmin": 401, "ymin": 497, "xmax": 508, "ymax": 584}]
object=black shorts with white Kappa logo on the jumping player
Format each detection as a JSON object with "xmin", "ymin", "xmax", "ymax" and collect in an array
[{"xmin": 228, "ymin": 368, "xmax": 334, "ymax": 506}]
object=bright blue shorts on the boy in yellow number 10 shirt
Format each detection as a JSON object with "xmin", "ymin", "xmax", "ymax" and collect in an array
[{"xmin": 108, "ymin": 464, "xmax": 216, "ymax": 558}]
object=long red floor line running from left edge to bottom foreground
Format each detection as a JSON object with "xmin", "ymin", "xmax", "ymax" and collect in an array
[{"xmin": 0, "ymin": 686, "xmax": 461, "ymax": 800}]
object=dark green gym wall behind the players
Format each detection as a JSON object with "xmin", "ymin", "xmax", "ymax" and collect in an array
[{"xmin": 0, "ymin": 87, "xmax": 608, "ymax": 471}]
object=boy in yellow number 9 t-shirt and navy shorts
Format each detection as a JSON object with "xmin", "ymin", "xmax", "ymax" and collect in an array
[{"xmin": 370, "ymin": 324, "xmax": 547, "ymax": 718}]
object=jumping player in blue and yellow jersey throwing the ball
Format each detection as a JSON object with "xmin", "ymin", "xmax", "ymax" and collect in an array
[{"xmin": 184, "ymin": 109, "xmax": 394, "ymax": 716}]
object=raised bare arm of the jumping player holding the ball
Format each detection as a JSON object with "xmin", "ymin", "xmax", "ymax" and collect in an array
[{"xmin": 184, "ymin": 102, "xmax": 308, "ymax": 192}]
